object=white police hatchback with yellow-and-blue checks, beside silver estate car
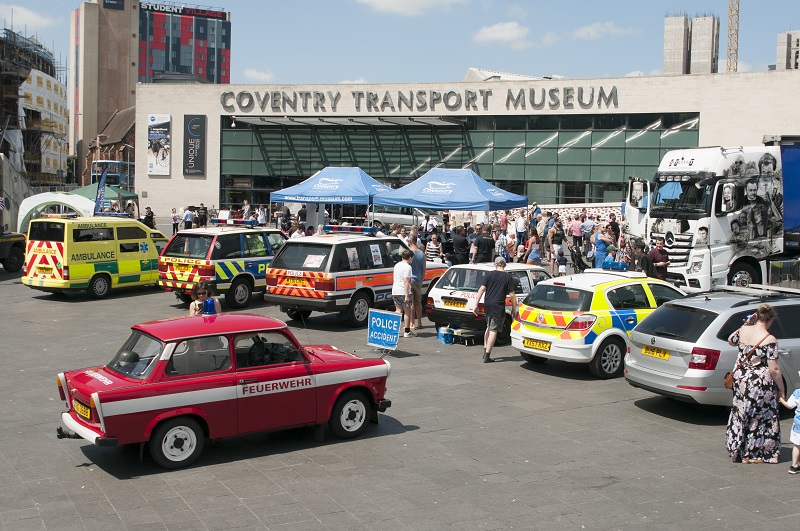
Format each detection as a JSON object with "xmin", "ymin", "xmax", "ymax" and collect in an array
[{"xmin": 511, "ymin": 269, "xmax": 685, "ymax": 378}]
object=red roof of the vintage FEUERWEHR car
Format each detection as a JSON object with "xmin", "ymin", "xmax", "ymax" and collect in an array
[{"xmin": 131, "ymin": 313, "xmax": 286, "ymax": 341}]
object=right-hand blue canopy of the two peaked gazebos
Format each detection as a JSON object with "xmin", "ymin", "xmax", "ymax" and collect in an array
[{"xmin": 374, "ymin": 168, "xmax": 528, "ymax": 210}]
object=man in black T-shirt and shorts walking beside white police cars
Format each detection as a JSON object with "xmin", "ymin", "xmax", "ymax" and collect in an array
[{"xmin": 473, "ymin": 256, "xmax": 517, "ymax": 363}]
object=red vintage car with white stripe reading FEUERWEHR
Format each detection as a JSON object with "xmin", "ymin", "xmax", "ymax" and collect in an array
[{"xmin": 57, "ymin": 314, "xmax": 391, "ymax": 468}]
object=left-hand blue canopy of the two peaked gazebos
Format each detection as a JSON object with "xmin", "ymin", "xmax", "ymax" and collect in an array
[{"xmin": 269, "ymin": 167, "xmax": 391, "ymax": 205}]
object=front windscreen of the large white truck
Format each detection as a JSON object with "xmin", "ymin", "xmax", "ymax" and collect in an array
[{"xmin": 650, "ymin": 174, "xmax": 714, "ymax": 215}]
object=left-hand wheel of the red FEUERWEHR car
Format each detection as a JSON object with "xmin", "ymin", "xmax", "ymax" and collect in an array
[{"xmin": 150, "ymin": 417, "xmax": 205, "ymax": 468}]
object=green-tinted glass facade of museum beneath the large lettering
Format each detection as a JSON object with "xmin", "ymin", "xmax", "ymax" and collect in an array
[{"xmin": 220, "ymin": 113, "xmax": 700, "ymax": 208}]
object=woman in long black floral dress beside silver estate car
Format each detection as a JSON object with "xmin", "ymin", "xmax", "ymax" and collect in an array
[{"xmin": 726, "ymin": 304, "xmax": 786, "ymax": 463}]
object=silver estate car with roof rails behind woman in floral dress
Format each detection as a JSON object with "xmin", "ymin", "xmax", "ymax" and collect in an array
[{"xmin": 624, "ymin": 286, "xmax": 800, "ymax": 406}]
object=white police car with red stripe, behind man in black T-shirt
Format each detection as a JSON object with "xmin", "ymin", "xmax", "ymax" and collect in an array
[{"xmin": 425, "ymin": 262, "xmax": 550, "ymax": 344}]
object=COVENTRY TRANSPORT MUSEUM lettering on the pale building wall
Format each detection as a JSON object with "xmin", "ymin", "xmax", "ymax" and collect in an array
[{"xmin": 220, "ymin": 86, "xmax": 619, "ymax": 114}]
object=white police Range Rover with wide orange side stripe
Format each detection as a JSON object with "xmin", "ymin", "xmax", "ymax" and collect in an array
[{"xmin": 264, "ymin": 227, "xmax": 447, "ymax": 326}]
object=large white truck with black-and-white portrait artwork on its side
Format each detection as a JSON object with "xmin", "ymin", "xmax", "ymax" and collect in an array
[{"xmin": 625, "ymin": 136, "xmax": 800, "ymax": 291}]
